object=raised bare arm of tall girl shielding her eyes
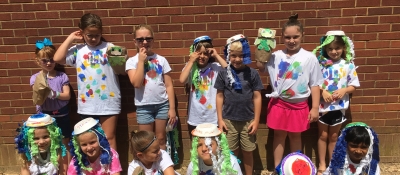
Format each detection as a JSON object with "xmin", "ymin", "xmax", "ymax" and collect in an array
[{"xmin": 53, "ymin": 30, "xmax": 83, "ymax": 64}]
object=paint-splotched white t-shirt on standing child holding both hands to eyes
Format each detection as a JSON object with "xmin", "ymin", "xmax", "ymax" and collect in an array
[{"xmin": 187, "ymin": 62, "xmax": 224, "ymax": 126}]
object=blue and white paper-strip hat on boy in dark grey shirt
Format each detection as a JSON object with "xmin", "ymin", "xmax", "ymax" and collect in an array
[{"xmin": 224, "ymin": 34, "xmax": 251, "ymax": 90}]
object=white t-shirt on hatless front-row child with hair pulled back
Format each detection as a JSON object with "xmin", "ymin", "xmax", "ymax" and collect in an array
[{"xmin": 128, "ymin": 150, "xmax": 174, "ymax": 175}]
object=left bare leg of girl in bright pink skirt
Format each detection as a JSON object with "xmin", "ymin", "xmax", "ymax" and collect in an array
[{"xmin": 272, "ymin": 130, "xmax": 287, "ymax": 167}]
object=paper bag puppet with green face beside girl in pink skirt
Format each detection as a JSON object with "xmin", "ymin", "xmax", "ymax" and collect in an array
[{"xmin": 254, "ymin": 28, "xmax": 276, "ymax": 62}]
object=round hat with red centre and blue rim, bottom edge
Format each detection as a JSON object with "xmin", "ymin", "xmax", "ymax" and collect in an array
[{"xmin": 277, "ymin": 152, "xmax": 316, "ymax": 175}]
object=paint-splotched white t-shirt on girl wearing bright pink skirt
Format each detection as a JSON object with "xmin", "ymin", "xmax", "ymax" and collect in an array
[{"xmin": 264, "ymin": 49, "xmax": 324, "ymax": 103}]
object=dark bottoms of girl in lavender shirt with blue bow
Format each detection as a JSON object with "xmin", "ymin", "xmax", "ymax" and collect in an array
[{"xmin": 42, "ymin": 105, "xmax": 72, "ymax": 138}]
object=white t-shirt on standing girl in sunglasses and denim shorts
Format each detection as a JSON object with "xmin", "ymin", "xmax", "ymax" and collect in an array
[{"xmin": 126, "ymin": 54, "xmax": 171, "ymax": 106}]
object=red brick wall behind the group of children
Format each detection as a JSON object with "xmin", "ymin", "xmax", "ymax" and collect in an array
[{"xmin": 0, "ymin": 0, "xmax": 400, "ymax": 173}]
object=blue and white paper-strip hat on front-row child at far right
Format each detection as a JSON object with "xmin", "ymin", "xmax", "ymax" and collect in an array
[{"xmin": 326, "ymin": 122, "xmax": 380, "ymax": 175}]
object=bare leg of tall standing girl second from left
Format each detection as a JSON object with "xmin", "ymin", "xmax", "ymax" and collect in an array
[{"xmin": 100, "ymin": 115, "xmax": 118, "ymax": 150}]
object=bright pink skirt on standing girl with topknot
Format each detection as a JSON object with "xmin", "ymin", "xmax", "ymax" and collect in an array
[{"xmin": 267, "ymin": 98, "xmax": 310, "ymax": 132}]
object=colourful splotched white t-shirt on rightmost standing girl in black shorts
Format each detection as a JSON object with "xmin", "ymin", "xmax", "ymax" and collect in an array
[{"xmin": 319, "ymin": 59, "xmax": 360, "ymax": 112}]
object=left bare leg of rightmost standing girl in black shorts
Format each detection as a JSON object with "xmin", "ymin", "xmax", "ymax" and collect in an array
[{"xmin": 318, "ymin": 122, "xmax": 328, "ymax": 175}]
